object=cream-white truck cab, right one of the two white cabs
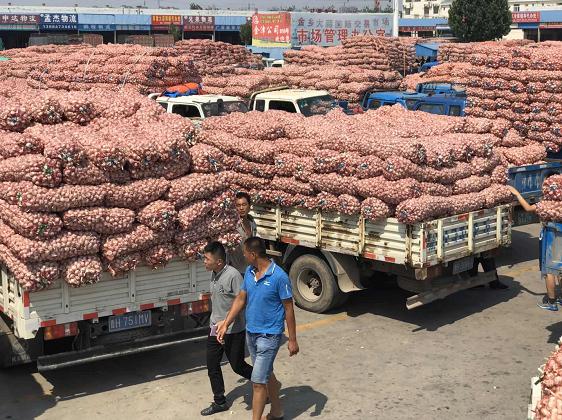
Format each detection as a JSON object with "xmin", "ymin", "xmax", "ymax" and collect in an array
[{"xmin": 250, "ymin": 88, "xmax": 342, "ymax": 117}]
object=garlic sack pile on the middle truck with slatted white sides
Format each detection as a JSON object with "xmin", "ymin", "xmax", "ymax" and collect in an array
[{"xmin": 197, "ymin": 106, "xmax": 512, "ymax": 223}]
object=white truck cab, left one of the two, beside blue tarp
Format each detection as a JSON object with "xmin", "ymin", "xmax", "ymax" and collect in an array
[{"xmin": 149, "ymin": 93, "xmax": 248, "ymax": 121}]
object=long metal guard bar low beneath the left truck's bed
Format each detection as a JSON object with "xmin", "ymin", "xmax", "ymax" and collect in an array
[{"xmin": 37, "ymin": 327, "xmax": 209, "ymax": 372}]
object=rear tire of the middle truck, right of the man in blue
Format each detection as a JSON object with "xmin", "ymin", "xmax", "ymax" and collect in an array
[{"xmin": 289, "ymin": 255, "xmax": 347, "ymax": 313}]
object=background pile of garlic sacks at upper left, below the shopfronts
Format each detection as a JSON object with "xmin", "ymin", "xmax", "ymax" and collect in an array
[{"xmin": 0, "ymin": 44, "xmax": 201, "ymax": 93}]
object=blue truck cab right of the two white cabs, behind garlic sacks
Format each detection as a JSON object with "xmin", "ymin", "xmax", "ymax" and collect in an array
[{"xmin": 362, "ymin": 92, "xmax": 466, "ymax": 117}]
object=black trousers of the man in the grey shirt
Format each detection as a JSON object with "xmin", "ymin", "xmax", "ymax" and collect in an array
[{"xmin": 207, "ymin": 331, "xmax": 252, "ymax": 404}]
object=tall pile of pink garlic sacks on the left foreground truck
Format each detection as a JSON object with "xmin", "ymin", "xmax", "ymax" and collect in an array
[{"xmin": 0, "ymin": 82, "xmax": 240, "ymax": 290}]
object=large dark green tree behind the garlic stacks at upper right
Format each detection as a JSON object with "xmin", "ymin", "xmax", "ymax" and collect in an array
[{"xmin": 449, "ymin": 0, "xmax": 512, "ymax": 42}]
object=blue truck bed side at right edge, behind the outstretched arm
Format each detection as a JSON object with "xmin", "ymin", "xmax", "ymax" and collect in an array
[{"xmin": 508, "ymin": 162, "xmax": 562, "ymax": 202}]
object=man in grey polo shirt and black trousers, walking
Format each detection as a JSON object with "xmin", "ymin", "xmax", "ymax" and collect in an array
[{"xmin": 201, "ymin": 242, "xmax": 252, "ymax": 416}]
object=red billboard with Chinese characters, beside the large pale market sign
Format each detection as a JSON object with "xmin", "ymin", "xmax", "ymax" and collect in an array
[{"xmin": 252, "ymin": 12, "xmax": 291, "ymax": 47}]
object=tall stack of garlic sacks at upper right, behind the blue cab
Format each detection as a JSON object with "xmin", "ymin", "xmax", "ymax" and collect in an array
[{"xmin": 402, "ymin": 41, "xmax": 562, "ymax": 165}]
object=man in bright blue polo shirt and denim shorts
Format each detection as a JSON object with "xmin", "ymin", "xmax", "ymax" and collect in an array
[{"xmin": 217, "ymin": 237, "xmax": 299, "ymax": 420}]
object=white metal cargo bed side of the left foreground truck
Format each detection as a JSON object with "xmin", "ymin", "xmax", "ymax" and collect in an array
[{"xmin": 0, "ymin": 260, "xmax": 211, "ymax": 339}]
